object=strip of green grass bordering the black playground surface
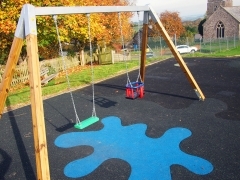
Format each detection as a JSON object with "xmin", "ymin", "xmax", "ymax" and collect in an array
[{"xmin": 2, "ymin": 47, "xmax": 240, "ymax": 108}]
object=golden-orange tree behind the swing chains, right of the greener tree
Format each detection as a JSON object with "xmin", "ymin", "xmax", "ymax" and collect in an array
[{"xmin": 54, "ymin": 0, "xmax": 132, "ymax": 64}]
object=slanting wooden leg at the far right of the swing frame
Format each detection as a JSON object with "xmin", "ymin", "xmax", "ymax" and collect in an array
[{"xmin": 149, "ymin": 7, "xmax": 205, "ymax": 101}]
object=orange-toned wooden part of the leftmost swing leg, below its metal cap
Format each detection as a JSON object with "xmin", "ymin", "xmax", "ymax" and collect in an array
[{"xmin": 0, "ymin": 37, "xmax": 23, "ymax": 118}]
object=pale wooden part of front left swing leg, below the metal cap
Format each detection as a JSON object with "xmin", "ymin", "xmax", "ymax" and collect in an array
[{"xmin": 26, "ymin": 34, "xmax": 50, "ymax": 180}]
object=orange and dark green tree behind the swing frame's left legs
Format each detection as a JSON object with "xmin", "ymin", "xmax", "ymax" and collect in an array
[{"xmin": 0, "ymin": 0, "xmax": 74, "ymax": 63}]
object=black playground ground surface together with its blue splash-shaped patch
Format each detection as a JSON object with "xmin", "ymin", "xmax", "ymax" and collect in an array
[{"xmin": 0, "ymin": 58, "xmax": 240, "ymax": 180}]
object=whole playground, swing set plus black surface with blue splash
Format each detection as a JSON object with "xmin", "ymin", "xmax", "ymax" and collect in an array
[{"xmin": 0, "ymin": 4, "xmax": 240, "ymax": 180}]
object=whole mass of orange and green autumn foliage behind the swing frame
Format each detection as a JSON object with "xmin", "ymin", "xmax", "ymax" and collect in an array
[{"xmin": 0, "ymin": 0, "xmax": 132, "ymax": 63}]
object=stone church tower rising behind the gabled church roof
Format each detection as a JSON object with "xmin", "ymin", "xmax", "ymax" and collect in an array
[{"xmin": 207, "ymin": 0, "xmax": 232, "ymax": 17}]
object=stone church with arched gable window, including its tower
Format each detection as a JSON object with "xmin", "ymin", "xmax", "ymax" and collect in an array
[{"xmin": 203, "ymin": 0, "xmax": 240, "ymax": 41}]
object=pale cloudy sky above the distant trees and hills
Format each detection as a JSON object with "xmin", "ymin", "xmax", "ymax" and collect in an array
[{"xmin": 133, "ymin": 0, "xmax": 240, "ymax": 20}]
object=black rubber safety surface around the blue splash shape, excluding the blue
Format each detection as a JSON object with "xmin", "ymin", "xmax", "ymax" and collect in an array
[{"xmin": 0, "ymin": 58, "xmax": 240, "ymax": 180}]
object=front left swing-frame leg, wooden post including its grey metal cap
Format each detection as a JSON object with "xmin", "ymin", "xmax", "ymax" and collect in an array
[{"xmin": 21, "ymin": 4, "xmax": 50, "ymax": 180}]
